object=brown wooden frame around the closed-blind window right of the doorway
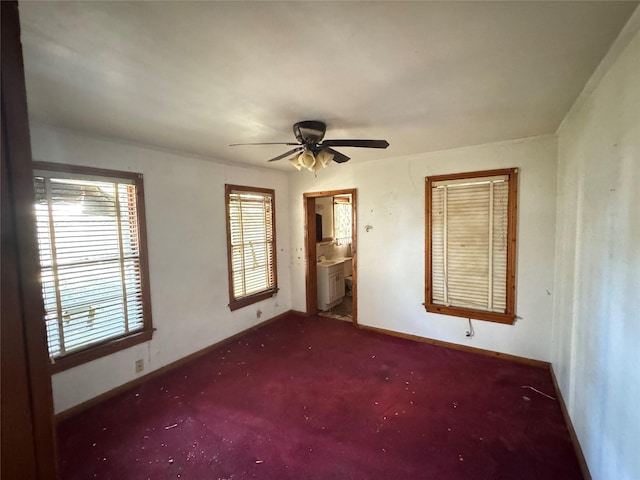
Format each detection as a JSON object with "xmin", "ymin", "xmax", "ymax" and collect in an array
[{"xmin": 424, "ymin": 168, "xmax": 518, "ymax": 325}]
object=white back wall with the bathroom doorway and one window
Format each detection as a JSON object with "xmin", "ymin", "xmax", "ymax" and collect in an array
[{"xmin": 289, "ymin": 136, "xmax": 556, "ymax": 361}]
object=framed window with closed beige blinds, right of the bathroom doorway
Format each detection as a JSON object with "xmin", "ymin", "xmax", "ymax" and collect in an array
[{"xmin": 425, "ymin": 169, "xmax": 518, "ymax": 324}]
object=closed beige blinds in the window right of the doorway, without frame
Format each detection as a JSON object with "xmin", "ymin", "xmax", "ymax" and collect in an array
[{"xmin": 430, "ymin": 175, "xmax": 509, "ymax": 313}]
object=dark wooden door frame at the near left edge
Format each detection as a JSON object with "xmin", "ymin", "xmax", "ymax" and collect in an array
[{"xmin": 0, "ymin": 1, "xmax": 57, "ymax": 480}]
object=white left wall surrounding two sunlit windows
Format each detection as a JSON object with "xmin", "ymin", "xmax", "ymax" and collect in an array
[{"xmin": 31, "ymin": 125, "xmax": 291, "ymax": 412}]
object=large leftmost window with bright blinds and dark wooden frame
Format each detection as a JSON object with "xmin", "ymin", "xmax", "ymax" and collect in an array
[{"xmin": 34, "ymin": 162, "xmax": 152, "ymax": 371}]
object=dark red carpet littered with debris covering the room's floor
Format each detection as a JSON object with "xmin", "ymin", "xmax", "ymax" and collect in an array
[{"xmin": 59, "ymin": 315, "xmax": 582, "ymax": 480}]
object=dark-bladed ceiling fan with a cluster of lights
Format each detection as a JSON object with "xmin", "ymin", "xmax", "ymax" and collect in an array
[{"xmin": 230, "ymin": 120, "xmax": 389, "ymax": 170}]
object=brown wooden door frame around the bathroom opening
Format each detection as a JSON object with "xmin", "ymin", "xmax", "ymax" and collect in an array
[{"xmin": 303, "ymin": 188, "xmax": 358, "ymax": 325}]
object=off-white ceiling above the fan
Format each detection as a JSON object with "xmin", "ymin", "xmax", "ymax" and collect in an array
[{"xmin": 20, "ymin": 1, "xmax": 637, "ymax": 169}]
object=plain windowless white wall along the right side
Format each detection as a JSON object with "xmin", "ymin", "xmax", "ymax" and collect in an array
[{"xmin": 552, "ymin": 27, "xmax": 640, "ymax": 480}]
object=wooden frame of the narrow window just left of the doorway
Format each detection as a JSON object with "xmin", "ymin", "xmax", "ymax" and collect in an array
[{"xmin": 224, "ymin": 184, "xmax": 278, "ymax": 311}]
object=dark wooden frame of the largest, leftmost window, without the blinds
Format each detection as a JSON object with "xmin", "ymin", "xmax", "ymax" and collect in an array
[{"xmin": 33, "ymin": 162, "xmax": 154, "ymax": 373}]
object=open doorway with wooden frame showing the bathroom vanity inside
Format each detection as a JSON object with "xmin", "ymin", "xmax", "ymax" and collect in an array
[{"xmin": 304, "ymin": 189, "xmax": 358, "ymax": 325}]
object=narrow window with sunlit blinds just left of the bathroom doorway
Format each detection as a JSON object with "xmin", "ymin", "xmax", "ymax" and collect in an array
[{"xmin": 225, "ymin": 185, "xmax": 278, "ymax": 310}]
